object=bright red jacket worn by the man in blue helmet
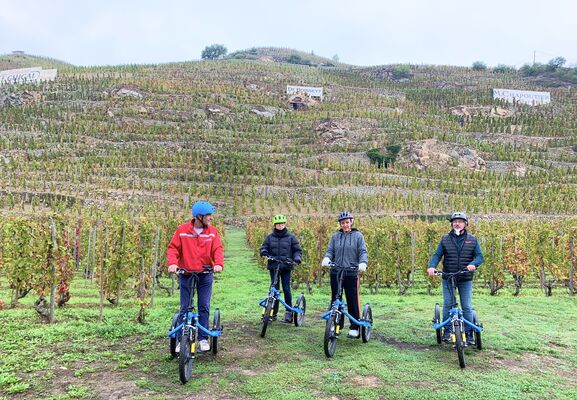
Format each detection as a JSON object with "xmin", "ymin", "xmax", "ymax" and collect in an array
[{"xmin": 166, "ymin": 222, "xmax": 224, "ymax": 272}]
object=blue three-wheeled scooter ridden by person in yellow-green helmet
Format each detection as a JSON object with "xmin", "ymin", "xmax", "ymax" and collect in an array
[{"xmin": 258, "ymin": 256, "xmax": 306, "ymax": 337}]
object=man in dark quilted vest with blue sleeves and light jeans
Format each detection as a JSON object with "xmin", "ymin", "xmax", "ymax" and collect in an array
[{"xmin": 427, "ymin": 212, "xmax": 483, "ymax": 344}]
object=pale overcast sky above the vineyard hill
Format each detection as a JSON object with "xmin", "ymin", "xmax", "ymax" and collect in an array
[{"xmin": 0, "ymin": 0, "xmax": 577, "ymax": 67}]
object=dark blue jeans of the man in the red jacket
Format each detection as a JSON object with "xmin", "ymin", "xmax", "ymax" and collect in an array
[{"xmin": 178, "ymin": 273, "xmax": 213, "ymax": 340}]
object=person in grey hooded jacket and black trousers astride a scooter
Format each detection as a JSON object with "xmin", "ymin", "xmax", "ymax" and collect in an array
[{"xmin": 322, "ymin": 211, "xmax": 369, "ymax": 338}]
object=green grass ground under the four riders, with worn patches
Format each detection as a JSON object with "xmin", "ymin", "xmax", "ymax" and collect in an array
[{"xmin": 0, "ymin": 230, "xmax": 577, "ymax": 399}]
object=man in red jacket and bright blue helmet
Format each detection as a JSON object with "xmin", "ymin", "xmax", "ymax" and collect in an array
[{"xmin": 166, "ymin": 201, "xmax": 224, "ymax": 351}]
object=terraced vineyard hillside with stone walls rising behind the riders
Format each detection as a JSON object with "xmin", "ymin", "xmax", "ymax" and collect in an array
[{"xmin": 0, "ymin": 54, "xmax": 577, "ymax": 217}]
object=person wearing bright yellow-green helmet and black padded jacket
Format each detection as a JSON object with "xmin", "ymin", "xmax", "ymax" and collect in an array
[{"xmin": 260, "ymin": 214, "xmax": 302, "ymax": 324}]
